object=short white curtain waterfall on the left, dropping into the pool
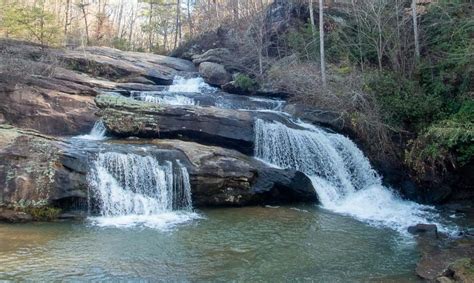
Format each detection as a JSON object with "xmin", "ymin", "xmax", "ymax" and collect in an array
[{"xmin": 88, "ymin": 152, "xmax": 198, "ymax": 230}]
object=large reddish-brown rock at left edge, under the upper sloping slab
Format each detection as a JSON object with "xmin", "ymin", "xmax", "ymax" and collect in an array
[{"xmin": 0, "ymin": 74, "xmax": 98, "ymax": 135}]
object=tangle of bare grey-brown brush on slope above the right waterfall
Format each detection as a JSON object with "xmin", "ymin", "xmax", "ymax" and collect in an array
[{"xmin": 266, "ymin": 56, "xmax": 394, "ymax": 161}]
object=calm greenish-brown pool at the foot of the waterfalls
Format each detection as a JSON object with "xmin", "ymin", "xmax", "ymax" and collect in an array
[{"xmin": 0, "ymin": 206, "xmax": 419, "ymax": 282}]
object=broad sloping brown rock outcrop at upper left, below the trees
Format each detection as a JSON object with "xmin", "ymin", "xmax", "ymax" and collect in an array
[{"xmin": 0, "ymin": 39, "xmax": 196, "ymax": 136}]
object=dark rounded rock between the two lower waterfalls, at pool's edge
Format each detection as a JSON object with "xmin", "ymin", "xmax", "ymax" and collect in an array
[{"xmin": 146, "ymin": 140, "xmax": 317, "ymax": 207}]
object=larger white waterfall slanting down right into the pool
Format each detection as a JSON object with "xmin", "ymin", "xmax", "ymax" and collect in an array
[{"xmin": 255, "ymin": 119, "xmax": 443, "ymax": 233}]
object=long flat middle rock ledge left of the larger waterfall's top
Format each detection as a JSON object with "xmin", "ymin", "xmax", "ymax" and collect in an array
[{"xmin": 95, "ymin": 94, "xmax": 285, "ymax": 154}]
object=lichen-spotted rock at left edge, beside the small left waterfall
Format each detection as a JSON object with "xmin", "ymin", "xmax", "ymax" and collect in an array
[{"xmin": 0, "ymin": 125, "xmax": 87, "ymax": 209}]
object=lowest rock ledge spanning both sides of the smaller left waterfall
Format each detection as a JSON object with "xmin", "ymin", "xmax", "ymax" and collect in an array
[{"xmin": 0, "ymin": 126, "xmax": 317, "ymax": 219}]
